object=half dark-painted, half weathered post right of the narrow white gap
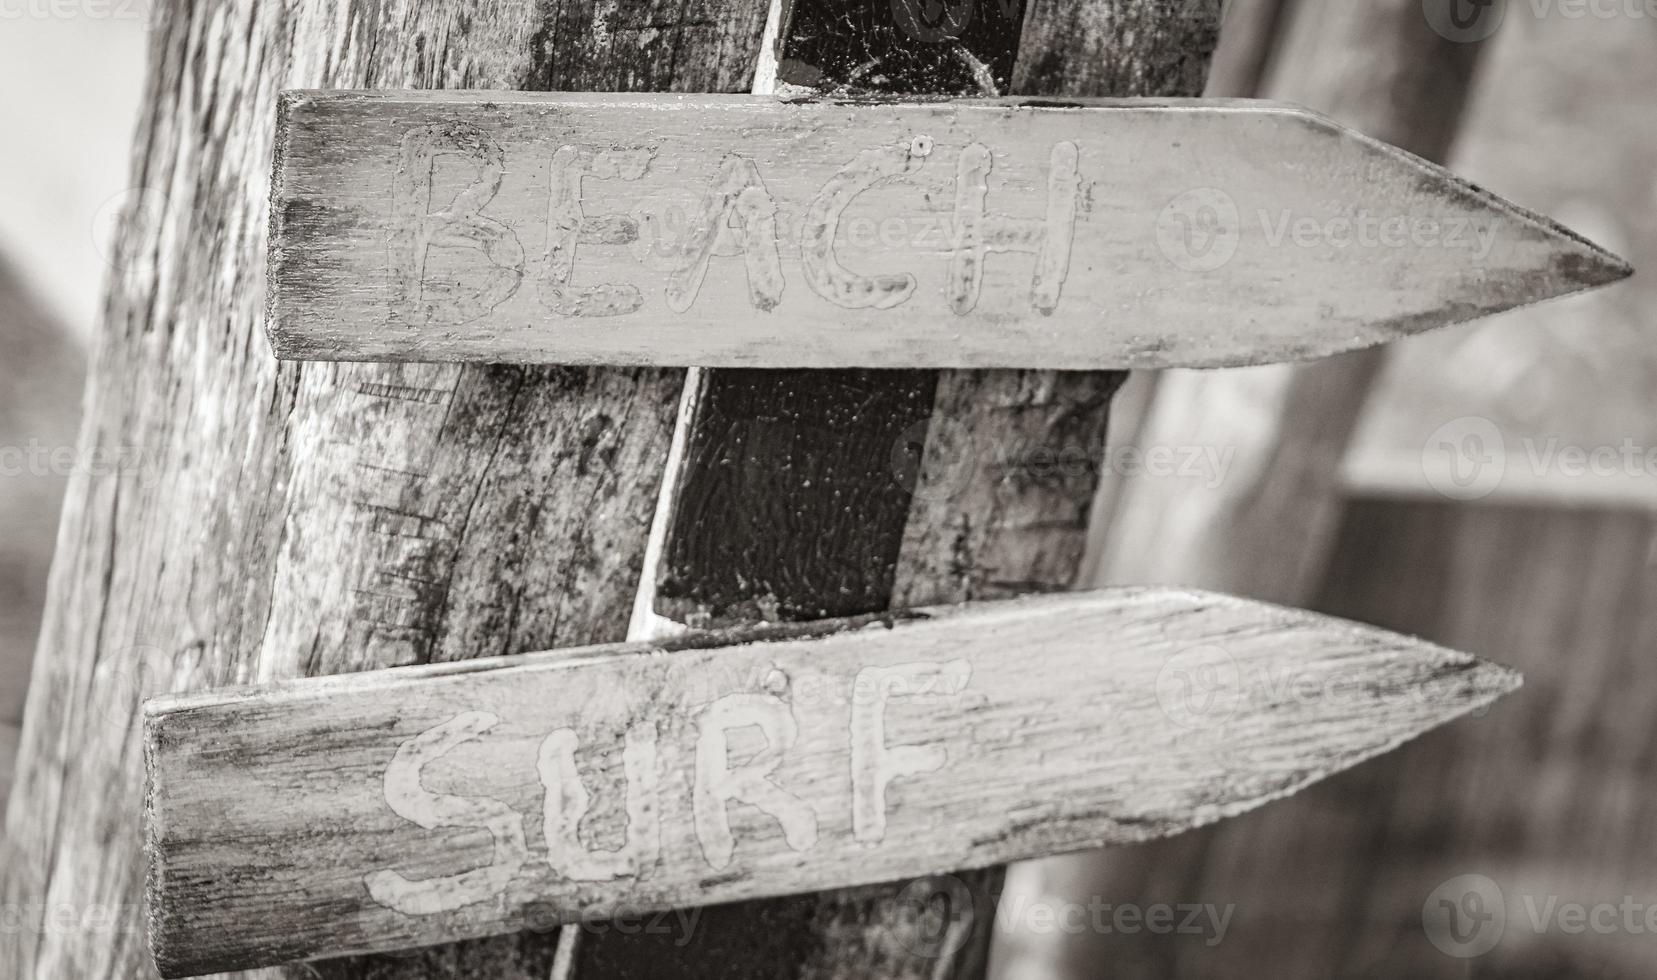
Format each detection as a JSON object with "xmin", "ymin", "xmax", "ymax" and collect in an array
[{"xmin": 575, "ymin": 0, "xmax": 1220, "ymax": 980}]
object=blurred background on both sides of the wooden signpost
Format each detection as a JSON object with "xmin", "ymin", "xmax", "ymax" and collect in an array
[{"xmin": 0, "ymin": 0, "xmax": 1657, "ymax": 980}]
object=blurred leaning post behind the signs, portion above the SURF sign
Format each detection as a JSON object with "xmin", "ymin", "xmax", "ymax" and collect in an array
[{"xmin": 1095, "ymin": 0, "xmax": 1481, "ymax": 605}]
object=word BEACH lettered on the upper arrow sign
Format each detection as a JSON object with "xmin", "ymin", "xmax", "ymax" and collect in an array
[{"xmin": 389, "ymin": 123, "xmax": 1082, "ymax": 325}]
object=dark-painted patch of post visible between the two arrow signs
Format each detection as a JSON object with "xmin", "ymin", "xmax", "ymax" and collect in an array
[{"xmin": 656, "ymin": 371, "xmax": 936, "ymax": 628}]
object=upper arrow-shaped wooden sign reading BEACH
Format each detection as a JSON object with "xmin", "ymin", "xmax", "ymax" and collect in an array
[{"xmin": 268, "ymin": 91, "xmax": 1629, "ymax": 368}]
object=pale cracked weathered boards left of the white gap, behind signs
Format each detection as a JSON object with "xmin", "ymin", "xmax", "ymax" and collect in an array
[{"xmin": 0, "ymin": 0, "xmax": 766, "ymax": 980}]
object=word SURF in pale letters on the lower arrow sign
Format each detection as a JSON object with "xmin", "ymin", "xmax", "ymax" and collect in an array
[{"xmin": 363, "ymin": 660, "xmax": 973, "ymax": 915}]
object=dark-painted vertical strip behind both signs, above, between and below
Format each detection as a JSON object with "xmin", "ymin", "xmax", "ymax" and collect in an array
[{"xmin": 575, "ymin": 0, "xmax": 1021, "ymax": 980}]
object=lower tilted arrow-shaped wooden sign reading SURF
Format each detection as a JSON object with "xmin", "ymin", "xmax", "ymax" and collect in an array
[{"xmin": 146, "ymin": 590, "xmax": 1518, "ymax": 977}]
